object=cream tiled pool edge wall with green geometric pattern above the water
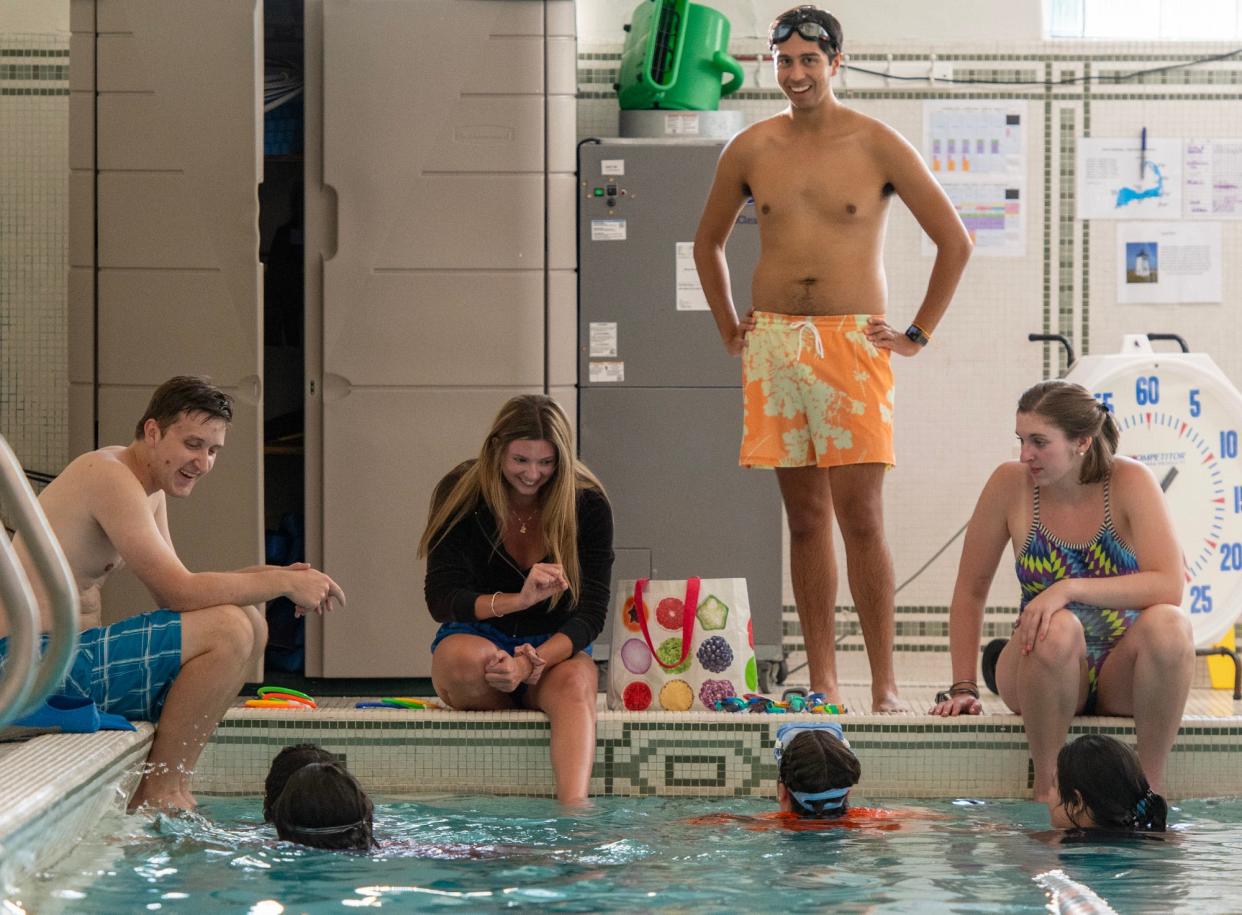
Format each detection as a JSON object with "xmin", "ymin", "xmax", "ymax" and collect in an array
[{"xmin": 194, "ymin": 710, "xmax": 1242, "ymax": 797}]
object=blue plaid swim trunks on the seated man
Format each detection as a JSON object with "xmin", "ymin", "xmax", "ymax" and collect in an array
[{"xmin": 0, "ymin": 610, "xmax": 181, "ymax": 721}]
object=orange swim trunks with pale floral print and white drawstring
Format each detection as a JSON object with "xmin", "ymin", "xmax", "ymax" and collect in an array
[{"xmin": 739, "ymin": 312, "xmax": 893, "ymax": 467}]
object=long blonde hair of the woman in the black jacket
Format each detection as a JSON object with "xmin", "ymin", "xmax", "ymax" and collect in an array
[{"xmin": 419, "ymin": 394, "xmax": 606, "ymax": 603}]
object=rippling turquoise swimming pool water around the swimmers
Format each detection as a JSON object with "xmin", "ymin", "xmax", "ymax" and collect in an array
[{"xmin": 9, "ymin": 797, "xmax": 1242, "ymax": 915}]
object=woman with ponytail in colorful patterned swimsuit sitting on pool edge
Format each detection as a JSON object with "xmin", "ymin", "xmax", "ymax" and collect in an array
[{"xmin": 932, "ymin": 381, "xmax": 1195, "ymax": 808}]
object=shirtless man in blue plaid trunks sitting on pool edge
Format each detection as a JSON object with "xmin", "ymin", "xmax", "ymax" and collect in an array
[{"xmin": 0, "ymin": 376, "xmax": 345, "ymax": 809}]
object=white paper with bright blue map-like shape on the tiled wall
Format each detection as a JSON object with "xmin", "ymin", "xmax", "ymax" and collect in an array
[{"xmin": 1074, "ymin": 137, "xmax": 1182, "ymax": 220}]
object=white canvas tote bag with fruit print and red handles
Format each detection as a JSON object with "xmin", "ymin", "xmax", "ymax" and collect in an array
[{"xmin": 609, "ymin": 579, "xmax": 758, "ymax": 711}]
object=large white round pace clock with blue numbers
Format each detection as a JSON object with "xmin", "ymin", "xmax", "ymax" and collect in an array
[{"xmin": 1089, "ymin": 355, "xmax": 1242, "ymax": 646}]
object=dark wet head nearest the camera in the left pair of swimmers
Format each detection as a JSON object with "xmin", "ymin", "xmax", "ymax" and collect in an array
[{"xmin": 272, "ymin": 762, "xmax": 375, "ymax": 852}]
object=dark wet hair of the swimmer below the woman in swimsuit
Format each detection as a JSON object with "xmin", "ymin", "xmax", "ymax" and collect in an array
[{"xmin": 1057, "ymin": 734, "xmax": 1169, "ymax": 832}]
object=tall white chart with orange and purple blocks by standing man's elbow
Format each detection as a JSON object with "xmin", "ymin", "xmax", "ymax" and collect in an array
[{"xmin": 923, "ymin": 101, "xmax": 1027, "ymax": 257}]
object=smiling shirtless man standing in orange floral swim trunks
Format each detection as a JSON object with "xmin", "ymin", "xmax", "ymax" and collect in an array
[{"xmin": 694, "ymin": 6, "xmax": 971, "ymax": 711}]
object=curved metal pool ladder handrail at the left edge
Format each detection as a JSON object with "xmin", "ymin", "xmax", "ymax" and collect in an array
[{"xmin": 0, "ymin": 436, "xmax": 81, "ymax": 728}]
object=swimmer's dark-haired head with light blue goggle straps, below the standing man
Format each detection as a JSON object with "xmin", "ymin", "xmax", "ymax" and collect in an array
[{"xmin": 774, "ymin": 721, "xmax": 862, "ymax": 817}]
